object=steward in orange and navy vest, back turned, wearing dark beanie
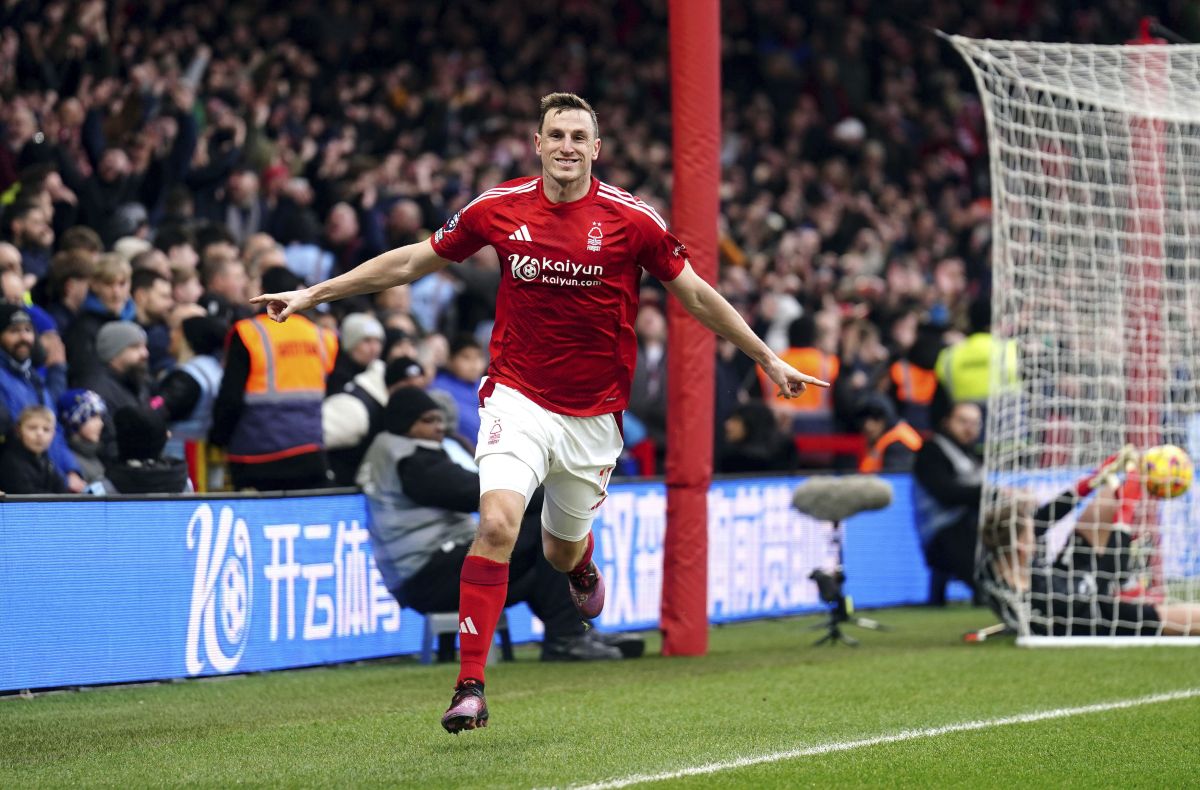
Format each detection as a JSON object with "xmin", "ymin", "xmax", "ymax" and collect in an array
[{"xmin": 209, "ymin": 269, "xmax": 337, "ymax": 491}]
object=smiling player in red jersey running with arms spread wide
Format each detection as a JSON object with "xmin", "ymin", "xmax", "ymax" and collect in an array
[{"xmin": 251, "ymin": 94, "xmax": 828, "ymax": 732}]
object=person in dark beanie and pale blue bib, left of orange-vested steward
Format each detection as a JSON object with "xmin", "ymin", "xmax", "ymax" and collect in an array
[{"xmin": 158, "ymin": 305, "xmax": 229, "ymax": 459}]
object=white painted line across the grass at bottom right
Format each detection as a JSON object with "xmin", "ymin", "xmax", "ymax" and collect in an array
[{"xmin": 561, "ymin": 688, "xmax": 1200, "ymax": 790}]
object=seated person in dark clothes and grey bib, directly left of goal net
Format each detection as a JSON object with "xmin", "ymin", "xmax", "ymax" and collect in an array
[{"xmin": 912, "ymin": 391, "xmax": 983, "ymax": 606}]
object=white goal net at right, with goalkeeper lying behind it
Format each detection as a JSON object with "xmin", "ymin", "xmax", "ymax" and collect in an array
[{"xmin": 949, "ymin": 36, "xmax": 1200, "ymax": 645}]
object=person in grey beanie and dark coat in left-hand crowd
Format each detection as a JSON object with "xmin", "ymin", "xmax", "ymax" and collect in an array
[{"xmin": 82, "ymin": 321, "xmax": 150, "ymax": 466}]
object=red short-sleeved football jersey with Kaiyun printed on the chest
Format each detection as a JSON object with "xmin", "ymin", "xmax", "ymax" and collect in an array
[{"xmin": 431, "ymin": 178, "xmax": 685, "ymax": 417}]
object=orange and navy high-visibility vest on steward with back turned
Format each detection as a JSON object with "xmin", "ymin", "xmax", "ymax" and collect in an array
[{"xmin": 228, "ymin": 315, "xmax": 337, "ymax": 463}]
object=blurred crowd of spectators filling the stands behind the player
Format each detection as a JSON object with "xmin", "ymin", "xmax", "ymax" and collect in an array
[{"xmin": 0, "ymin": 0, "xmax": 1185, "ymax": 492}]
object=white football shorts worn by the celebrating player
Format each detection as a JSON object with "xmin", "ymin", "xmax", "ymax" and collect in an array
[{"xmin": 475, "ymin": 384, "xmax": 623, "ymax": 541}]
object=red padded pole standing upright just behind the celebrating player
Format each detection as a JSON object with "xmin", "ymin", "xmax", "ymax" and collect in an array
[{"xmin": 660, "ymin": 0, "xmax": 721, "ymax": 656}]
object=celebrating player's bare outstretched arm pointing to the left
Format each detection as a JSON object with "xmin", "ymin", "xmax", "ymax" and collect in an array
[{"xmin": 250, "ymin": 239, "xmax": 450, "ymax": 322}]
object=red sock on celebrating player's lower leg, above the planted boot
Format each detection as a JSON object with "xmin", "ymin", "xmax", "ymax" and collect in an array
[{"xmin": 458, "ymin": 555, "xmax": 509, "ymax": 683}]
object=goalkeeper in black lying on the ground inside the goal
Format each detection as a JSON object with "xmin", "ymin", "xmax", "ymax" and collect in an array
[{"xmin": 978, "ymin": 447, "xmax": 1200, "ymax": 636}]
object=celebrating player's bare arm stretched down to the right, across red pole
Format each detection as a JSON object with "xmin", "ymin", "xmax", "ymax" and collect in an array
[{"xmin": 662, "ymin": 263, "xmax": 829, "ymax": 397}]
